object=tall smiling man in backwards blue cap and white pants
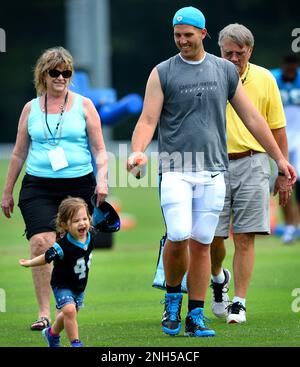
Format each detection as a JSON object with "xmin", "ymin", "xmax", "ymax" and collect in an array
[{"xmin": 127, "ymin": 7, "xmax": 296, "ymax": 337}]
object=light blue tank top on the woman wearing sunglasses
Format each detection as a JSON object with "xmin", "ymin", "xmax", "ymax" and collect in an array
[{"xmin": 26, "ymin": 94, "xmax": 93, "ymax": 178}]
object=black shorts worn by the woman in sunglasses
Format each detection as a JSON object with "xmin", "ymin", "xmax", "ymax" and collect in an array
[{"xmin": 18, "ymin": 173, "xmax": 96, "ymax": 240}]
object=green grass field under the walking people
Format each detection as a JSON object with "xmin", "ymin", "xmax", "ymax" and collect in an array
[{"xmin": 0, "ymin": 161, "xmax": 300, "ymax": 347}]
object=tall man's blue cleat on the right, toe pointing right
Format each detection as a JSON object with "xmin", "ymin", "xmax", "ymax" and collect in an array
[{"xmin": 184, "ymin": 307, "xmax": 216, "ymax": 337}]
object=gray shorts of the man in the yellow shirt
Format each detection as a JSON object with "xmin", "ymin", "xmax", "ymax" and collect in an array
[{"xmin": 215, "ymin": 153, "xmax": 271, "ymax": 238}]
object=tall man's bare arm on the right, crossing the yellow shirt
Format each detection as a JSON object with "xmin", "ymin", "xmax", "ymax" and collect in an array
[{"xmin": 230, "ymin": 81, "xmax": 297, "ymax": 184}]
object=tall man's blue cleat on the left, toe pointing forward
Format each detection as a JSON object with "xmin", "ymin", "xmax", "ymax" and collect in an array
[{"xmin": 161, "ymin": 293, "xmax": 182, "ymax": 335}]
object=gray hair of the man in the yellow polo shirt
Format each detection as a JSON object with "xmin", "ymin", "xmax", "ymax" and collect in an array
[{"xmin": 218, "ymin": 23, "xmax": 254, "ymax": 48}]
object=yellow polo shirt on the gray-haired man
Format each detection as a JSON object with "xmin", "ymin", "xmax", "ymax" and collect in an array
[{"xmin": 226, "ymin": 64, "xmax": 286, "ymax": 153}]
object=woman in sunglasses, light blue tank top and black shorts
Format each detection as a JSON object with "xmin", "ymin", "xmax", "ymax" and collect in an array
[{"xmin": 1, "ymin": 47, "xmax": 108, "ymax": 330}]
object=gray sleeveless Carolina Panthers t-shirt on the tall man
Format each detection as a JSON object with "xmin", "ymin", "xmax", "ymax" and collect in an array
[{"xmin": 156, "ymin": 53, "xmax": 239, "ymax": 173}]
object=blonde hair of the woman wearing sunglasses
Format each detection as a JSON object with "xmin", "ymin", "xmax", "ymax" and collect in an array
[{"xmin": 34, "ymin": 46, "xmax": 74, "ymax": 96}]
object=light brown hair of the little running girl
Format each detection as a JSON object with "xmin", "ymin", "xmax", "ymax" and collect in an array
[{"xmin": 56, "ymin": 196, "xmax": 92, "ymax": 234}]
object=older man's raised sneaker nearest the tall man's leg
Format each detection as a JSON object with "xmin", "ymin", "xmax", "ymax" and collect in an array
[{"xmin": 210, "ymin": 269, "xmax": 231, "ymax": 318}]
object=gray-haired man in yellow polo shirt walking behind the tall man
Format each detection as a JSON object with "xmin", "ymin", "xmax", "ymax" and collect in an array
[{"xmin": 211, "ymin": 24, "xmax": 290, "ymax": 323}]
